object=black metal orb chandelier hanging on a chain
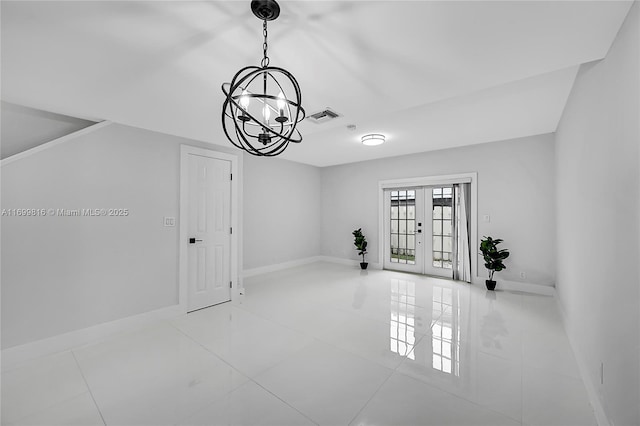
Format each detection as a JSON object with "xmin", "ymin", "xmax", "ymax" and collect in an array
[{"xmin": 222, "ymin": 0, "xmax": 305, "ymax": 157}]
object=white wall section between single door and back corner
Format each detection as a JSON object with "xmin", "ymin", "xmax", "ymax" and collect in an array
[{"xmin": 243, "ymin": 154, "xmax": 322, "ymax": 270}]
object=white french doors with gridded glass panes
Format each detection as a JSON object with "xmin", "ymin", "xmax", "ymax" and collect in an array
[{"xmin": 383, "ymin": 185, "xmax": 457, "ymax": 277}]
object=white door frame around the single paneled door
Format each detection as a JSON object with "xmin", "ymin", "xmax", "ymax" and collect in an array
[{"xmin": 178, "ymin": 145, "xmax": 241, "ymax": 313}]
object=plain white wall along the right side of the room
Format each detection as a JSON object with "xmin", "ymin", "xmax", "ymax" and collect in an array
[{"xmin": 556, "ymin": 2, "xmax": 640, "ymax": 425}]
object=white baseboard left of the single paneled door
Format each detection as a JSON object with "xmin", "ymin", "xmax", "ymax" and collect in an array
[{"xmin": 2, "ymin": 305, "xmax": 185, "ymax": 371}]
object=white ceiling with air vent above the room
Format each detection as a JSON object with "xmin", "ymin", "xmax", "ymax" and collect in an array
[{"xmin": 1, "ymin": 0, "xmax": 632, "ymax": 166}]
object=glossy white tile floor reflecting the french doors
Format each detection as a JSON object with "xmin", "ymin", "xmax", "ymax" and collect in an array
[{"xmin": 2, "ymin": 263, "xmax": 596, "ymax": 425}]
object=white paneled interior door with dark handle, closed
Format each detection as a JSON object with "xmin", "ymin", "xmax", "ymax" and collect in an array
[{"xmin": 183, "ymin": 154, "xmax": 231, "ymax": 311}]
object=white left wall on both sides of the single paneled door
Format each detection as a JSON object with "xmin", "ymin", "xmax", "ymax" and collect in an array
[{"xmin": 1, "ymin": 115, "xmax": 321, "ymax": 349}]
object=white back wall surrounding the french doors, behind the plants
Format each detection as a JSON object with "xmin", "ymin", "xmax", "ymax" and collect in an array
[{"xmin": 322, "ymin": 135, "xmax": 555, "ymax": 286}]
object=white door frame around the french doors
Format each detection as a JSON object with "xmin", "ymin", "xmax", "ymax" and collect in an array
[{"xmin": 378, "ymin": 172, "xmax": 482, "ymax": 284}]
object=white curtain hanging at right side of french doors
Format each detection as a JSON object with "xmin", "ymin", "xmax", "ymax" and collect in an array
[{"xmin": 453, "ymin": 183, "xmax": 471, "ymax": 283}]
